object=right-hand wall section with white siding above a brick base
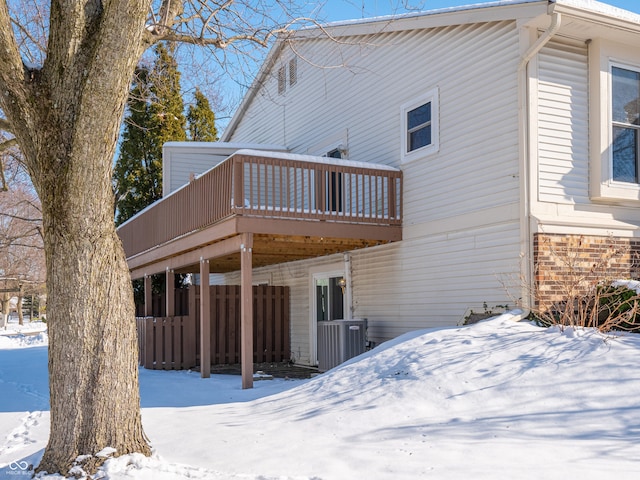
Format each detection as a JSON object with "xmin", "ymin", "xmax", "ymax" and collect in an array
[{"xmin": 532, "ymin": 36, "xmax": 640, "ymax": 316}]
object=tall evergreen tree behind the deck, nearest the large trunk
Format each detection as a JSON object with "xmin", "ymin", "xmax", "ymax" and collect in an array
[{"xmin": 114, "ymin": 43, "xmax": 186, "ymax": 225}]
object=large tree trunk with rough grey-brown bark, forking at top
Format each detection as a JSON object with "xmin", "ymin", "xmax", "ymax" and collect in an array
[{"xmin": 0, "ymin": 0, "xmax": 150, "ymax": 475}]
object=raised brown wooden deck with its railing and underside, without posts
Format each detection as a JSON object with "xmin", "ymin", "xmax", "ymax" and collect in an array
[{"xmin": 118, "ymin": 151, "xmax": 402, "ymax": 278}]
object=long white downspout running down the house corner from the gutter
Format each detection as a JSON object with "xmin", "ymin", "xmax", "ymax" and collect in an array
[{"xmin": 518, "ymin": 5, "xmax": 562, "ymax": 318}]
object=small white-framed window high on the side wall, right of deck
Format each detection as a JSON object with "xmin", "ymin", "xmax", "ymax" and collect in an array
[{"xmin": 402, "ymin": 89, "xmax": 439, "ymax": 161}]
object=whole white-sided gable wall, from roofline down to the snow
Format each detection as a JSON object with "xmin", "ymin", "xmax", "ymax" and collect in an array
[{"xmin": 220, "ymin": 21, "xmax": 521, "ymax": 363}]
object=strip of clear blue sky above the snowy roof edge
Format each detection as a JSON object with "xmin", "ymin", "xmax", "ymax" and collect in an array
[{"xmin": 318, "ymin": 0, "xmax": 640, "ymax": 21}]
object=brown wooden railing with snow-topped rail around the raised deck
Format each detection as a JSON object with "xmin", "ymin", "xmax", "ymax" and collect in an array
[{"xmin": 118, "ymin": 153, "xmax": 402, "ymax": 257}]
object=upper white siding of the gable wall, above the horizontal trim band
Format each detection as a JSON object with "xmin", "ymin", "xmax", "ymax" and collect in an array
[{"xmin": 229, "ymin": 22, "xmax": 519, "ymax": 225}]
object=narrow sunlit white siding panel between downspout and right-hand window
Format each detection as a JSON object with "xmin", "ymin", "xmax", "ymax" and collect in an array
[{"xmin": 538, "ymin": 38, "xmax": 589, "ymax": 204}]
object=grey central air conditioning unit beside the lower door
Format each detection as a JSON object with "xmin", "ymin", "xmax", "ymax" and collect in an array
[{"xmin": 318, "ymin": 318, "xmax": 367, "ymax": 372}]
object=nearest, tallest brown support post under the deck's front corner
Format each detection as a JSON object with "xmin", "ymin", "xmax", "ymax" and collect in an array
[{"xmin": 240, "ymin": 233, "xmax": 253, "ymax": 389}]
